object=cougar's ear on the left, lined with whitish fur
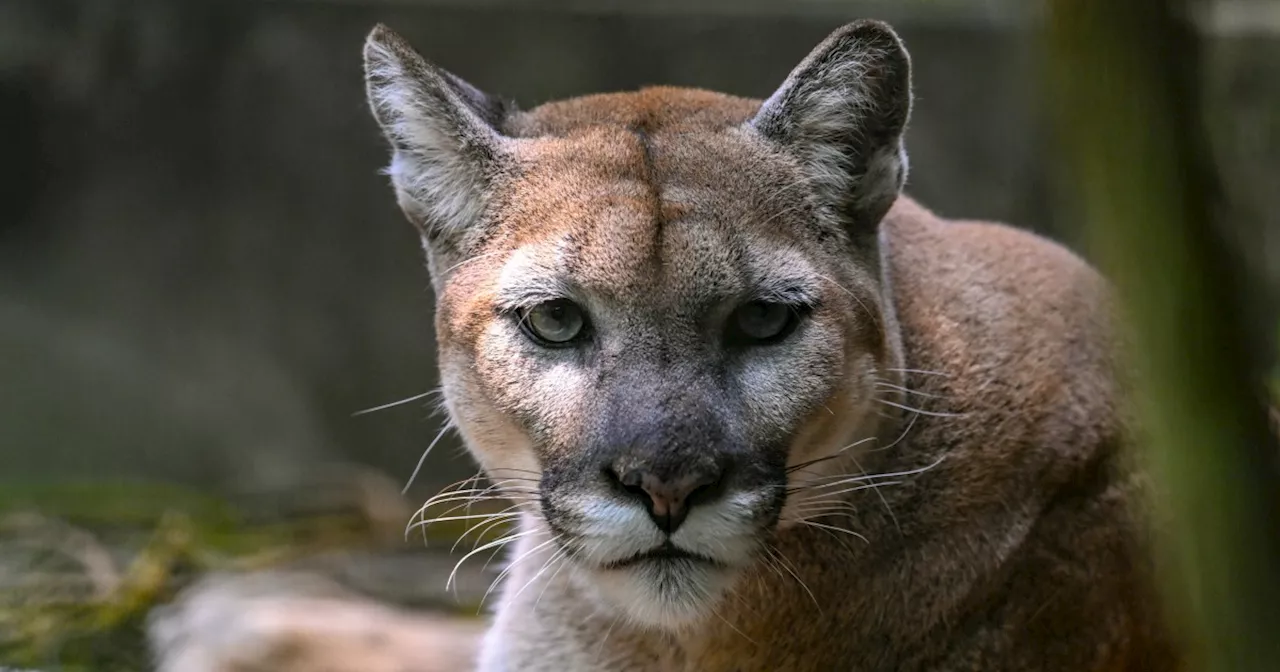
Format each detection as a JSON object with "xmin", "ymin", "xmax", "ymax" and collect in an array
[{"xmin": 365, "ymin": 24, "xmax": 511, "ymax": 252}]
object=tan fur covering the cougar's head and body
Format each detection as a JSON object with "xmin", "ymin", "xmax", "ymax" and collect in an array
[{"xmin": 366, "ymin": 18, "xmax": 1174, "ymax": 672}]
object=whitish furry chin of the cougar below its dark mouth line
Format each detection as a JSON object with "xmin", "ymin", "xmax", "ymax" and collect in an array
[{"xmin": 579, "ymin": 558, "xmax": 737, "ymax": 630}]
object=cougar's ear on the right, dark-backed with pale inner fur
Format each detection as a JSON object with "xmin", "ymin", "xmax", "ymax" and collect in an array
[{"xmin": 748, "ymin": 20, "xmax": 911, "ymax": 239}]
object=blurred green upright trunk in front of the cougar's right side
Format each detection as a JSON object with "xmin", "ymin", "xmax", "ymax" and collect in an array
[{"xmin": 1048, "ymin": 0, "xmax": 1280, "ymax": 672}]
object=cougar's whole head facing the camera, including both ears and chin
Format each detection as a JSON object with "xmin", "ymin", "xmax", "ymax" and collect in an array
[{"xmin": 365, "ymin": 22, "xmax": 910, "ymax": 627}]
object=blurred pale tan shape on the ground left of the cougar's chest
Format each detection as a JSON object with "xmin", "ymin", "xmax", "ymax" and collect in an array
[{"xmin": 147, "ymin": 572, "xmax": 484, "ymax": 672}]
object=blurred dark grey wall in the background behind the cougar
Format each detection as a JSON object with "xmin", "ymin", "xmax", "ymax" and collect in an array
[{"xmin": 0, "ymin": 0, "xmax": 1280, "ymax": 492}]
